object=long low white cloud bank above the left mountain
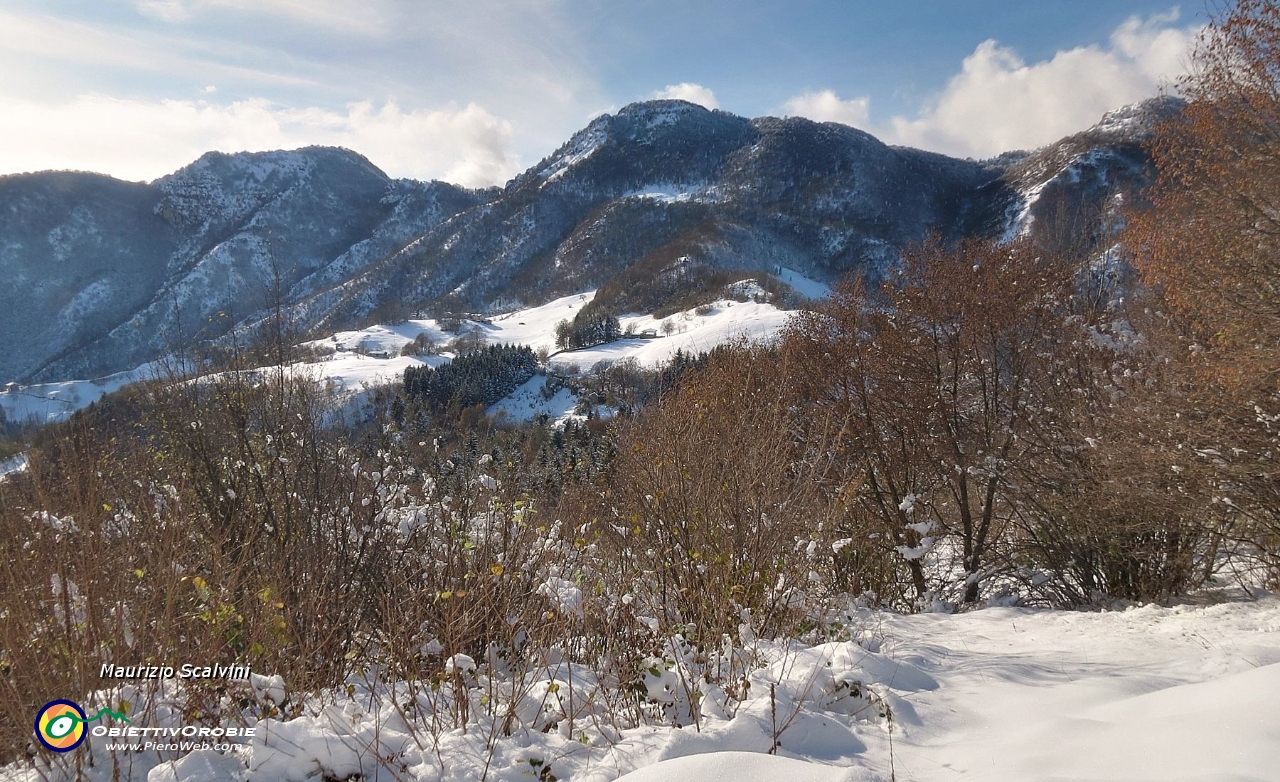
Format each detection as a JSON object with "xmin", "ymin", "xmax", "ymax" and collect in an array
[{"xmin": 0, "ymin": 96, "xmax": 518, "ymax": 187}]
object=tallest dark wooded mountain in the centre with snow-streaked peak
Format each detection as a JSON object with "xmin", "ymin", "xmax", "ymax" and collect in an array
[{"xmin": 299, "ymin": 101, "xmax": 1011, "ymax": 325}]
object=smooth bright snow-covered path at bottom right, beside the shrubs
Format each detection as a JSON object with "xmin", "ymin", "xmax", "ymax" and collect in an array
[{"xmin": 614, "ymin": 596, "xmax": 1280, "ymax": 782}]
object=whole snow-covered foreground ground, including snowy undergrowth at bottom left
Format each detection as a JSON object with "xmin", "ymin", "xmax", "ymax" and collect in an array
[{"xmin": 15, "ymin": 595, "xmax": 1280, "ymax": 782}]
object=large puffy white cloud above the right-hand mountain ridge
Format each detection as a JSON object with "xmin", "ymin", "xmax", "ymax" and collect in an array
[{"xmin": 786, "ymin": 12, "xmax": 1198, "ymax": 157}]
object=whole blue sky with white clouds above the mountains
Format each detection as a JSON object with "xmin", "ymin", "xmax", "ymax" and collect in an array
[{"xmin": 0, "ymin": 0, "xmax": 1207, "ymax": 187}]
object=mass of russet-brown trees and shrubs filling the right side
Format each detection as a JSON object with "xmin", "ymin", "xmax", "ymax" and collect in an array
[{"xmin": 609, "ymin": 0, "xmax": 1280, "ymax": 611}]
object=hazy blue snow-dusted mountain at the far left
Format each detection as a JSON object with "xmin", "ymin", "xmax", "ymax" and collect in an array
[{"xmin": 0, "ymin": 147, "xmax": 481, "ymax": 380}]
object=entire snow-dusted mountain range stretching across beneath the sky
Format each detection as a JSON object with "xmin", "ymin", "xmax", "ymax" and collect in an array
[{"xmin": 0, "ymin": 101, "xmax": 1172, "ymax": 381}]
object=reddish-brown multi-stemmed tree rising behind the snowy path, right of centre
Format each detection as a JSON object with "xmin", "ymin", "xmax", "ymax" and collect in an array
[{"xmin": 787, "ymin": 241, "xmax": 1080, "ymax": 603}]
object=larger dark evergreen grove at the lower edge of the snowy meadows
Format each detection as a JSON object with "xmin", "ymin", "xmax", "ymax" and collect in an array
[{"xmin": 404, "ymin": 344, "xmax": 538, "ymax": 408}]
